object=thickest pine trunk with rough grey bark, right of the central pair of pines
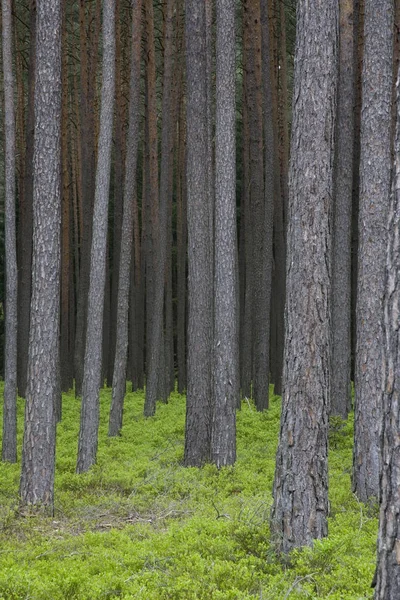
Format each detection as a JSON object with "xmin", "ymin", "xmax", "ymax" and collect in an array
[{"xmin": 271, "ymin": 0, "xmax": 339, "ymax": 552}]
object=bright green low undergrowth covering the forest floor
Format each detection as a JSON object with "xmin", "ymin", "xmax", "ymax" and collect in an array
[{"xmin": 0, "ymin": 390, "xmax": 377, "ymax": 600}]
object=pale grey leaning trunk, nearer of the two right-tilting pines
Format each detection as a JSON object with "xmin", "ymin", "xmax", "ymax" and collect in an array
[{"xmin": 76, "ymin": 0, "xmax": 115, "ymax": 473}]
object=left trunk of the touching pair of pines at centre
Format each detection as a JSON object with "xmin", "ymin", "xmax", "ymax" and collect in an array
[{"xmin": 184, "ymin": 0, "xmax": 213, "ymax": 466}]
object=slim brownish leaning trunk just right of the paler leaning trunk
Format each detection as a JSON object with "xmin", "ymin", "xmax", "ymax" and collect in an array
[{"xmin": 108, "ymin": 0, "xmax": 142, "ymax": 435}]
